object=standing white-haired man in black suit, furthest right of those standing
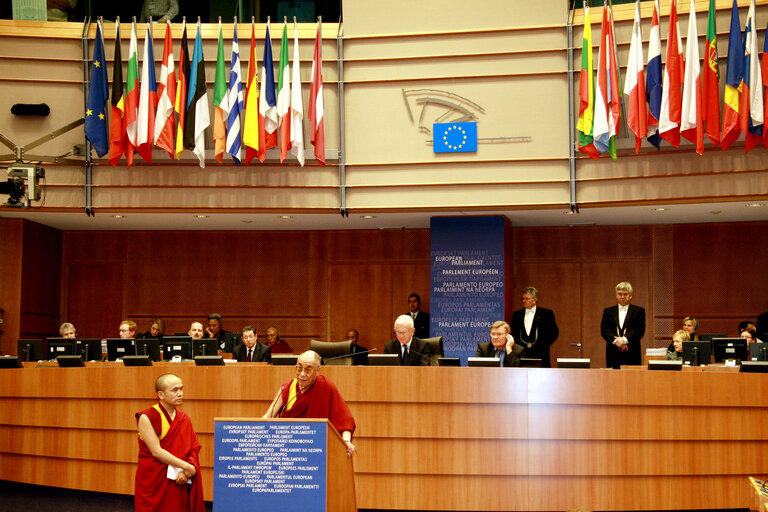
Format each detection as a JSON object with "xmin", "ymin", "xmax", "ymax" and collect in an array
[{"xmin": 600, "ymin": 282, "xmax": 645, "ymax": 369}]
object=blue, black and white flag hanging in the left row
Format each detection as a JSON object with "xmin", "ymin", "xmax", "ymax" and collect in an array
[{"xmin": 184, "ymin": 22, "xmax": 211, "ymax": 167}]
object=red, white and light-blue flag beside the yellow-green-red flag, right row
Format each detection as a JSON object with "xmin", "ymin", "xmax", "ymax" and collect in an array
[{"xmin": 593, "ymin": 2, "xmax": 620, "ymax": 160}]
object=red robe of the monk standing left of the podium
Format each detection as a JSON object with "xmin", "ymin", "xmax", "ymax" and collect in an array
[{"xmin": 134, "ymin": 403, "xmax": 205, "ymax": 512}]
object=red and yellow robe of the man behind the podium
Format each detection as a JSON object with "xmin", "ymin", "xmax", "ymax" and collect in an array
[{"xmin": 280, "ymin": 375, "xmax": 355, "ymax": 433}]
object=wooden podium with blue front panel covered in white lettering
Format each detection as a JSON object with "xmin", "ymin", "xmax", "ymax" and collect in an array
[{"xmin": 213, "ymin": 418, "xmax": 357, "ymax": 512}]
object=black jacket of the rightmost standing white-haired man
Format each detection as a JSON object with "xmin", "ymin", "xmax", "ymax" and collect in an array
[{"xmin": 600, "ymin": 304, "xmax": 645, "ymax": 368}]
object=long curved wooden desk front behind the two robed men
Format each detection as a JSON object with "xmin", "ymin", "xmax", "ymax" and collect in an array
[{"xmin": 0, "ymin": 363, "xmax": 768, "ymax": 510}]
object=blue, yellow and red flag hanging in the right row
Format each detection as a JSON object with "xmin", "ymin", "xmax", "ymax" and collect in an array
[{"xmin": 720, "ymin": 0, "xmax": 744, "ymax": 149}]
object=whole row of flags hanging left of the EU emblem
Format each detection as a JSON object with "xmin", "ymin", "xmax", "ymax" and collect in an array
[{"xmin": 85, "ymin": 21, "xmax": 325, "ymax": 167}]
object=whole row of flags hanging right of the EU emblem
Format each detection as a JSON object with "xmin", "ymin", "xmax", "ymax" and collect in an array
[{"xmin": 577, "ymin": 0, "xmax": 768, "ymax": 160}]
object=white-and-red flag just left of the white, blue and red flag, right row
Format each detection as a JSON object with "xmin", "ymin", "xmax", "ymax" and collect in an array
[{"xmin": 624, "ymin": 0, "xmax": 648, "ymax": 154}]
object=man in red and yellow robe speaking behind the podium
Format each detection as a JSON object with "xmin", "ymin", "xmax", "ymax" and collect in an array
[{"xmin": 263, "ymin": 350, "xmax": 355, "ymax": 455}]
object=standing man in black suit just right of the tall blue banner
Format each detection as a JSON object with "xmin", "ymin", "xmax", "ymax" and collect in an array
[{"xmin": 510, "ymin": 286, "xmax": 560, "ymax": 368}]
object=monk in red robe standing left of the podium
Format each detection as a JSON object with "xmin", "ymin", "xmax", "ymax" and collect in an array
[{"xmin": 134, "ymin": 373, "xmax": 205, "ymax": 512}]
